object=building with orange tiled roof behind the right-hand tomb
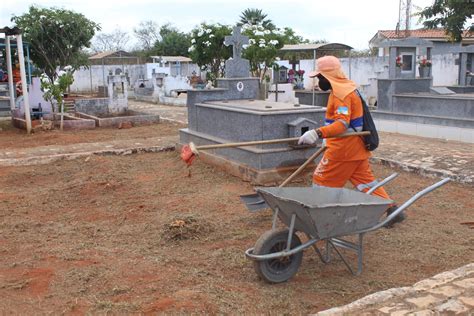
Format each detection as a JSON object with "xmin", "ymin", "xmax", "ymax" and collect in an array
[{"xmin": 369, "ymin": 29, "xmax": 474, "ymax": 56}]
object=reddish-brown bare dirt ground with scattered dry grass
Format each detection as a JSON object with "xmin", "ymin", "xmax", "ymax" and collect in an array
[{"xmin": 0, "ymin": 124, "xmax": 474, "ymax": 314}]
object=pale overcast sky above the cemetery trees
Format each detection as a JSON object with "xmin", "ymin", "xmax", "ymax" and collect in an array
[{"xmin": 0, "ymin": 0, "xmax": 433, "ymax": 49}]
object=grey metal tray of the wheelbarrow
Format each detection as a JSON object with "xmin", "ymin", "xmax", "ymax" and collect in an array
[{"xmin": 256, "ymin": 186, "xmax": 393, "ymax": 239}]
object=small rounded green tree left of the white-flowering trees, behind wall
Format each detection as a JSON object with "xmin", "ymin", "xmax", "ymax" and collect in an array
[{"xmin": 153, "ymin": 24, "xmax": 191, "ymax": 56}]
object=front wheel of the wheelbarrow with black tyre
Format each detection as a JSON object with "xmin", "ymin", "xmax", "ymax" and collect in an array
[{"xmin": 253, "ymin": 228, "xmax": 303, "ymax": 283}]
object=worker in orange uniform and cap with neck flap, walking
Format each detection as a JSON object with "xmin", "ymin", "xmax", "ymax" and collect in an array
[{"xmin": 298, "ymin": 56, "xmax": 405, "ymax": 226}]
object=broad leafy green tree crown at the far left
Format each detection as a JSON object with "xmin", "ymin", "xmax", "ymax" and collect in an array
[{"xmin": 12, "ymin": 6, "xmax": 100, "ymax": 81}]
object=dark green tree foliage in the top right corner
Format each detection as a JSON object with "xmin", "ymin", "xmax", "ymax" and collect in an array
[{"xmin": 417, "ymin": 0, "xmax": 474, "ymax": 42}]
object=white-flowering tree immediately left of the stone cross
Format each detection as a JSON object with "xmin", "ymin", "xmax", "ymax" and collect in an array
[{"xmin": 188, "ymin": 23, "xmax": 232, "ymax": 79}]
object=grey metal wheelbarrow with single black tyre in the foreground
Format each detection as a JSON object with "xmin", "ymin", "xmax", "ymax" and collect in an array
[{"xmin": 245, "ymin": 174, "xmax": 450, "ymax": 283}]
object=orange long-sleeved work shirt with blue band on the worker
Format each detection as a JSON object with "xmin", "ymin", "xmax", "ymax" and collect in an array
[{"xmin": 319, "ymin": 90, "xmax": 370, "ymax": 161}]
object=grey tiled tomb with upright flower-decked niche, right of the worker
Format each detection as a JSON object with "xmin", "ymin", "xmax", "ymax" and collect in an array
[{"xmin": 373, "ymin": 38, "xmax": 474, "ymax": 143}]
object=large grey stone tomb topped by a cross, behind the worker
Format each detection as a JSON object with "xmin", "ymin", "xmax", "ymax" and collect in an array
[{"xmin": 180, "ymin": 27, "xmax": 325, "ymax": 184}]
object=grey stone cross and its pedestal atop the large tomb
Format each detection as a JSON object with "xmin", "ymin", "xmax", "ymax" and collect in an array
[{"xmin": 224, "ymin": 26, "xmax": 250, "ymax": 78}]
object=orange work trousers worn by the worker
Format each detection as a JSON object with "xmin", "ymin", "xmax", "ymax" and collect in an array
[{"xmin": 313, "ymin": 156, "xmax": 391, "ymax": 200}]
